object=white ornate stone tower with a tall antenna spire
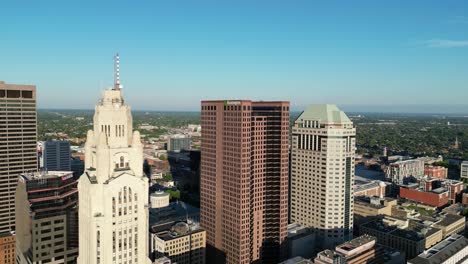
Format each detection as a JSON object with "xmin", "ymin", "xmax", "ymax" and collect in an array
[{"xmin": 78, "ymin": 54, "xmax": 150, "ymax": 264}]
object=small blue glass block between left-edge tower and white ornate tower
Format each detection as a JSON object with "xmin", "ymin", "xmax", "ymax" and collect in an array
[{"xmin": 42, "ymin": 140, "xmax": 71, "ymax": 171}]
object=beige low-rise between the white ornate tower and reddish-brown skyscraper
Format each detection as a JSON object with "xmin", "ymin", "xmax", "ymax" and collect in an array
[{"xmin": 150, "ymin": 222, "xmax": 206, "ymax": 264}]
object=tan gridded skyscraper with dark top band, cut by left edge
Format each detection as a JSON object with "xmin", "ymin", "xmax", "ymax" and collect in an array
[{"xmin": 0, "ymin": 82, "xmax": 37, "ymax": 262}]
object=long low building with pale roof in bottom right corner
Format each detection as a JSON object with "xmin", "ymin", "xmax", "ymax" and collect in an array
[{"xmin": 408, "ymin": 235, "xmax": 468, "ymax": 264}]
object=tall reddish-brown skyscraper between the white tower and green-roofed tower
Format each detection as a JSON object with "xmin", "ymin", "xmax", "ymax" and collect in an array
[{"xmin": 200, "ymin": 100, "xmax": 289, "ymax": 264}]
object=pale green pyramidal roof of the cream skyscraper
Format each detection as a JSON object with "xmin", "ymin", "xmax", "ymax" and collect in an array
[{"xmin": 298, "ymin": 104, "xmax": 351, "ymax": 123}]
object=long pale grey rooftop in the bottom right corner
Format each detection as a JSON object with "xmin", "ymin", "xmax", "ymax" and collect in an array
[{"xmin": 408, "ymin": 235, "xmax": 468, "ymax": 264}]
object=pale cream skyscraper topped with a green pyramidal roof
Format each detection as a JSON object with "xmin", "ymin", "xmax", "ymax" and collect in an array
[{"xmin": 291, "ymin": 105, "xmax": 356, "ymax": 247}]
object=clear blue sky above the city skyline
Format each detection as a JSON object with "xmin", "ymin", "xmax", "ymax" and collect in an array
[{"xmin": 0, "ymin": 0, "xmax": 468, "ymax": 113}]
